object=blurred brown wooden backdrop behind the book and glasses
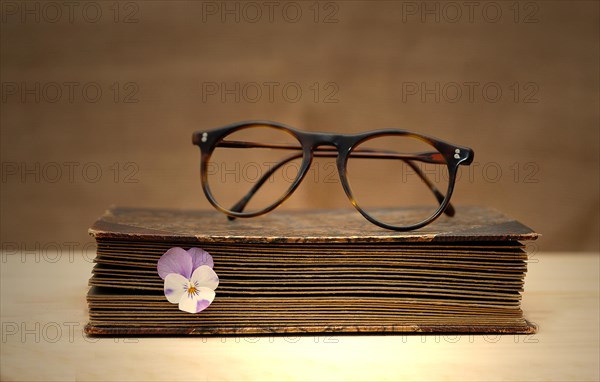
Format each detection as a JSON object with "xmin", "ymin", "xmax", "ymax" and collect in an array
[{"xmin": 0, "ymin": 1, "xmax": 600, "ymax": 251}]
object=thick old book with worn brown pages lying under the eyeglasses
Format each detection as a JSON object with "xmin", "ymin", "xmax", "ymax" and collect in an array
[{"xmin": 86, "ymin": 207, "xmax": 538, "ymax": 335}]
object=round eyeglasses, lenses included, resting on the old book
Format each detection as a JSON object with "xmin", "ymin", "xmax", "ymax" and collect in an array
[{"xmin": 192, "ymin": 121, "xmax": 474, "ymax": 231}]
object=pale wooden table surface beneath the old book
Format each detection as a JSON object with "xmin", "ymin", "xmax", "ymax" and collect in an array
[{"xmin": 0, "ymin": 251, "xmax": 600, "ymax": 381}]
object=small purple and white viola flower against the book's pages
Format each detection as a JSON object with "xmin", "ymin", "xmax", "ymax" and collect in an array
[{"xmin": 156, "ymin": 247, "xmax": 219, "ymax": 313}]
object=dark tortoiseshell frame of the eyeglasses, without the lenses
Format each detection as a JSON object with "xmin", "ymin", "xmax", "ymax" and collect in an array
[{"xmin": 192, "ymin": 121, "xmax": 474, "ymax": 231}]
